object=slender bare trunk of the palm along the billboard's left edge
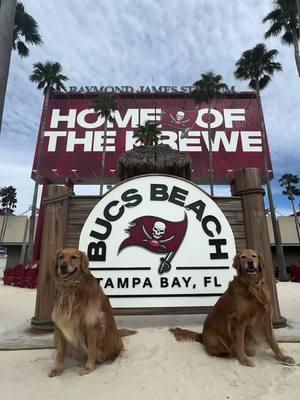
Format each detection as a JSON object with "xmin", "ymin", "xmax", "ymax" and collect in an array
[{"xmin": 26, "ymin": 86, "xmax": 51, "ymax": 261}]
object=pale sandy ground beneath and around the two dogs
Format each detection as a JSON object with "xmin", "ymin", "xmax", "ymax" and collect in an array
[{"xmin": 0, "ymin": 283, "xmax": 300, "ymax": 400}]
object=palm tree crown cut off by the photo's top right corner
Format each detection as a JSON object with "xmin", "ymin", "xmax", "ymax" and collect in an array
[{"xmin": 263, "ymin": 0, "xmax": 300, "ymax": 77}]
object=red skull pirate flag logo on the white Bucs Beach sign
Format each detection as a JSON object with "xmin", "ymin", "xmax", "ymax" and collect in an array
[{"xmin": 118, "ymin": 213, "xmax": 187, "ymax": 274}]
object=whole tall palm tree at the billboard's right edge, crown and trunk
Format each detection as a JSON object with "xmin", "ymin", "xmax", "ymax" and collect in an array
[{"xmin": 234, "ymin": 43, "xmax": 288, "ymax": 281}]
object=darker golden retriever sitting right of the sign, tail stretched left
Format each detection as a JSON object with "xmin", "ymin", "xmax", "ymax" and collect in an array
[{"xmin": 170, "ymin": 249, "xmax": 295, "ymax": 367}]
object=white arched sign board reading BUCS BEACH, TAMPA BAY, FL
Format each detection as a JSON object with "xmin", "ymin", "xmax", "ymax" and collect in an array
[{"xmin": 79, "ymin": 175, "xmax": 235, "ymax": 308}]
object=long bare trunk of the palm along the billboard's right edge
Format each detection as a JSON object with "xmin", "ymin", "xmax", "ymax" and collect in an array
[{"xmin": 256, "ymin": 86, "xmax": 289, "ymax": 282}]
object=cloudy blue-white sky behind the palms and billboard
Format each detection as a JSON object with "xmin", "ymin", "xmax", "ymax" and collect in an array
[{"xmin": 0, "ymin": 0, "xmax": 300, "ymax": 214}]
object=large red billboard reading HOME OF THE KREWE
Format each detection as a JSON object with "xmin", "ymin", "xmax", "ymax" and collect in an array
[{"xmin": 32, "ymin": 92, "xmax": 272, "ymax": 184}]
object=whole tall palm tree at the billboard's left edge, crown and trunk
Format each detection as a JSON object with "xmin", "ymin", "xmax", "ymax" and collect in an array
[{"xmin": 27, "ymin": 61, "xmax": 69, "ymax": 260}]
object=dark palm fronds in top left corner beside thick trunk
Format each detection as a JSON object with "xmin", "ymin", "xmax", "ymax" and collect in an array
[{"xmin": 12, "ymin": 1, "xmax": 43, "ymax": 57}]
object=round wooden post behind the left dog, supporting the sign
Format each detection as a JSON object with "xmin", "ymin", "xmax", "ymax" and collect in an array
[{"xmin": 31, "ymin": 185, "xmax": 72, "ymax": 330}]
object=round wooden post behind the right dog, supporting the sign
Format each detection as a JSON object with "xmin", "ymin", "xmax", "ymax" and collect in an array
[{"xmin": 235, "ymin": 168, "xmax": 286, "ymax": 328}]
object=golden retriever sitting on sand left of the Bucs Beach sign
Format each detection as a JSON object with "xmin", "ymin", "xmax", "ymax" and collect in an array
[{"xmin": 49, "ymin": 248, "xmax": 136, "ymax": 377}]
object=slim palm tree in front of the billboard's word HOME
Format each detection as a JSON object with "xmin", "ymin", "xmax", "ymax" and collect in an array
[{"xmin": 92, "ymin": 93, "xmax": 118, "ymax": 196}]
